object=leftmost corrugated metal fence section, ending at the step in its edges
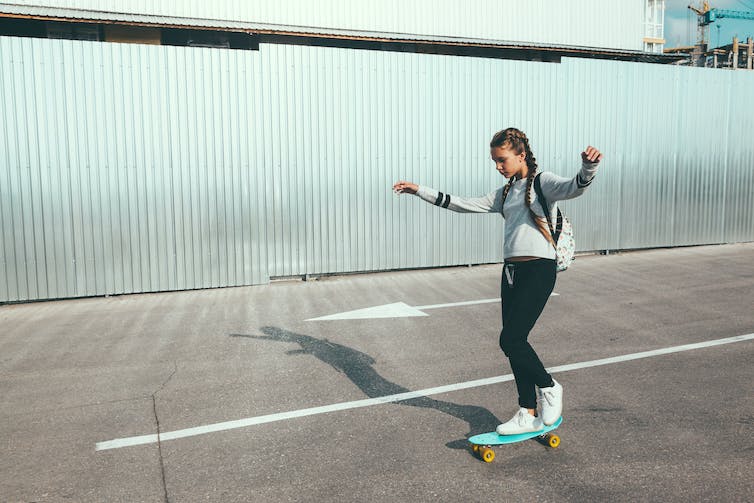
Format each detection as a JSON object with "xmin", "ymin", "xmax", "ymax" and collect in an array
[{"xmin": 0, "ymin": 37, "xmax": 268, "ymax": 301}]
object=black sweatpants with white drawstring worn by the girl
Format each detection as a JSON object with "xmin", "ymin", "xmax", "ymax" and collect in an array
[{"xmin": 500, "ymin": 259, "xmax": 556, "ymax": 409}]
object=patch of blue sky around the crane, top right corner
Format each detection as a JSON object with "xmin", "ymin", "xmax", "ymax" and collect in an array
[{"xmin": 665, "ymin": 0, "xmax": 754, "ymax": 48}]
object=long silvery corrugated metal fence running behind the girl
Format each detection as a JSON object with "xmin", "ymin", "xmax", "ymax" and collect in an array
[{"xmin": 0, "ymin": 37, "xmax": 754, "ymax": 302}]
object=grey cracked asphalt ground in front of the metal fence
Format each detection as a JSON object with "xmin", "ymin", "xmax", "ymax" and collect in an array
[{"xmin": 0, "ymin": 244, "xmax": 754, "ymax": 502}]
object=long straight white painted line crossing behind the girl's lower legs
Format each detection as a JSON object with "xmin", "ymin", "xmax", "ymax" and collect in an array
[{"xmin": 95, "ymin": 334, "xmax": 754, "ymax": 451}]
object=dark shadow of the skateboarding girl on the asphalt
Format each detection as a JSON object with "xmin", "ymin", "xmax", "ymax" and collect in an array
[{"xmin": 230, "ymin": 327, "xmax": 500, "ymax": 449}]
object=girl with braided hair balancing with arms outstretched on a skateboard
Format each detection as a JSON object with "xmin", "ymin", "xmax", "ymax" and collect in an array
[{"xmin": 393, "ymin": 128, "xmax": 602, "ymax": 435}]
